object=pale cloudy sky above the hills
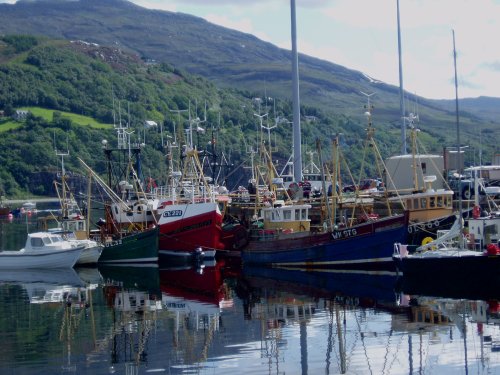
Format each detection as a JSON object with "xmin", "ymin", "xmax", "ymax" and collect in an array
[{"xmin": 0, "ymin": 0, "xmax": 500, "ymax": 99}]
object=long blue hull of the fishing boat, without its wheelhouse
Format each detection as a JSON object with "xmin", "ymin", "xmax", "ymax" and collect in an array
[{"xmin": 241, "ymin": 215, "xmax": 408, "ymax": 270}]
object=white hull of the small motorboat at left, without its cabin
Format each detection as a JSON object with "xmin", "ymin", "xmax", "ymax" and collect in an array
[{"xmin": 0, "ymin": 246, "xmax": 83, "ymax": 270}]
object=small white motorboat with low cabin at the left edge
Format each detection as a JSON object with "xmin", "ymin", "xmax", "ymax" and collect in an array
[{"xmin": 0, "ymin": 232, "xmax": 84, "ymax": 269}]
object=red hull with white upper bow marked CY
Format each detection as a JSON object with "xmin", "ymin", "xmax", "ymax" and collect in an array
[{"xmin": 159, "ymin": 202, "xmax": 224, "ymax": 261}]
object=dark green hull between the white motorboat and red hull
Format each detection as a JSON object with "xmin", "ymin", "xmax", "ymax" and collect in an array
[{"xmin": 98, "ymin": 227, "xmax": 158, "ymax": 264}]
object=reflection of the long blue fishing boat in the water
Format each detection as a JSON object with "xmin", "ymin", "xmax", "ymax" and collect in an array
[{"xmin": 235, "ymin": 266, "xmax": 407, "ymax": 374}]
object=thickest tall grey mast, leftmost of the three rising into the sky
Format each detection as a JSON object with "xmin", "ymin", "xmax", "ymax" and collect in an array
[{"xmin": 290, "ymin": 0, "xmax": 302, "ymax": 182}]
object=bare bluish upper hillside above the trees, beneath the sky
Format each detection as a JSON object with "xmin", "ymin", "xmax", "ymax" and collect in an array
[{"xmin": 0, "ymin": 0, "xmax": 500, "ymax": 153}]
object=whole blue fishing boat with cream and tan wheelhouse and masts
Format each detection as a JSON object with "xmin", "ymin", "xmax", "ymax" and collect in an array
[{"xmin": 241, "ymin": 105, "xmax": 408, "ymax": 270}]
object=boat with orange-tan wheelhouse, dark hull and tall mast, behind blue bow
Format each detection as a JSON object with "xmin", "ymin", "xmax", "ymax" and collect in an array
[{"xmin": 385, "ymin": 2, "xmax": 455, "ymax": 250}]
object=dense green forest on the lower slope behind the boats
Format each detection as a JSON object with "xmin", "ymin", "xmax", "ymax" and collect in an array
[{"xmin": 0, "ymin": 35, "xmax": 494, "ymax": 196}]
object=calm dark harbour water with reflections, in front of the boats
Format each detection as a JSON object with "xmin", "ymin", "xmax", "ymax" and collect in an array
[{"xmin": 0, "ymin": 210, "xmax": 500, "ymax": 375}]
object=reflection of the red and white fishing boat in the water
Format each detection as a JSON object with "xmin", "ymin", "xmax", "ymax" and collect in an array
[{"xmin": 160, "ymin": 261, "xmax": 238, "ymax": 373}]
